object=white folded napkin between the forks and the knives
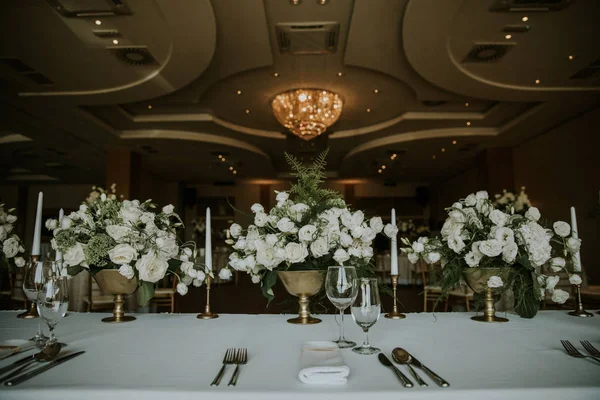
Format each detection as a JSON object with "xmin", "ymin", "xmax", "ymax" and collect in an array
[{"xmin": 298, "ymin": 341, "xmax": 350, "ymax": 385}]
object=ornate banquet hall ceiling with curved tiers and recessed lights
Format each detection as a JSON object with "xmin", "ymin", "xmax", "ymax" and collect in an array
[{"xmin": 0, "ymin": 0, "xmax": 600, "ymax": 183}]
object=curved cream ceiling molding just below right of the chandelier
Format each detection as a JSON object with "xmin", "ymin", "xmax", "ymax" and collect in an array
[{"xmin": 344, "ymin": 128, "xmax": 500, "ymax": 160}]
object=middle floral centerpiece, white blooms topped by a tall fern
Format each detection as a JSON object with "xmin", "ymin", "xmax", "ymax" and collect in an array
[{"xmin": 220, "ymin": 151, "xmax": 397, "ymax": 301}]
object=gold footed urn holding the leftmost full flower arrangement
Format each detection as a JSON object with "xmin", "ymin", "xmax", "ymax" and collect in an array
[{"xmin": 94, "ymin": 269, "xmax": 137, "ymax": 323}]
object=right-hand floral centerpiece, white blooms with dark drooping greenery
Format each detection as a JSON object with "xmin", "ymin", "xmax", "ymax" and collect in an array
[{"xmin": 402, "ymin": 191, "xmax": 581, "ymax": 318}]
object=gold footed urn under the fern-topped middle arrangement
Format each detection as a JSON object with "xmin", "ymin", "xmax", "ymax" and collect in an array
[{"xmin": 277, "ymin": 271, "xmax": 323, "ymax": 325}]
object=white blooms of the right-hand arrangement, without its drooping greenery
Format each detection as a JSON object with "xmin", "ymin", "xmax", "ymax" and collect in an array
[{"xmin": 402, "ymin": 191, "xmax": 581, "ymax": 303}]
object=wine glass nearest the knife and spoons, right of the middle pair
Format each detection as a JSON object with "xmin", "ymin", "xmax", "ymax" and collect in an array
[{"xmin": 351, "ymin": 278, "xmax": 381, "ymax": 354}]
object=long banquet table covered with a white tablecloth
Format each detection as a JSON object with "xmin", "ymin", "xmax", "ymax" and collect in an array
[{"xmin": 0, "ymin": 311, "xmax": 600, "ymax": 400}]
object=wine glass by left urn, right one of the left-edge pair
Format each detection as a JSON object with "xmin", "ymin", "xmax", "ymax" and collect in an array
[{"xmin": 37, "ymin": 263, "xmax": 69, "ymax": 345}]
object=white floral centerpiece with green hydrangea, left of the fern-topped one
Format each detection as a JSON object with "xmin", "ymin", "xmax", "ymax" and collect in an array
[{"xmin": 46, "ymin": 187, "xmax": 193, "ymax": 304}]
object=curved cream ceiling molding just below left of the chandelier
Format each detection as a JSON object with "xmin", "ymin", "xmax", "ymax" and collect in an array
[{"xmin": 120, "ymin": 129, "xmax": 271, "ymax": 161}]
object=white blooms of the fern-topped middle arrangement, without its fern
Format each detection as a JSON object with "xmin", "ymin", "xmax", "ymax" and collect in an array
[{"xmin": 219, "ymin": 191, "xmax": 398, "ymax": 283}]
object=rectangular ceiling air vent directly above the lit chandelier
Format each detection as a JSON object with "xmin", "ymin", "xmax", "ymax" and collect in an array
[{"xmin": 276, "ymin": 22, "xmax": 340, "ymax": 54}]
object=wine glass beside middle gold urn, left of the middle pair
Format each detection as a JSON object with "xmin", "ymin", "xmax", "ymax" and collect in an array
[{"xmin": 325, "ymin": 266, "xmax": 358, "ymax": 349}]
